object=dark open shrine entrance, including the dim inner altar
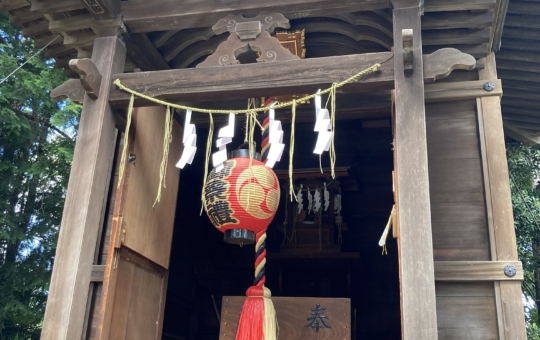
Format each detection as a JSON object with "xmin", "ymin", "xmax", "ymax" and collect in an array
[{"xmin": 163, "ymin": 105, "xmax": 401, "ymax": 340}]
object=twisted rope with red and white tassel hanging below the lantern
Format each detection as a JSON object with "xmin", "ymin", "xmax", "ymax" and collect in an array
[{"xmin": 236, "ymin": 232, "xmax": 277, "ymax": 340}]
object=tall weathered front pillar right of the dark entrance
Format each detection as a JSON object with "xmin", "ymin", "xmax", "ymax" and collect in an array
[{"xmin": 393, "ymin": 0, "xmax": 437, "ymax": 340}]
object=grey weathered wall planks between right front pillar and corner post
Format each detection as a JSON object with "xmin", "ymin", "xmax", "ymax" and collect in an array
[{"xmin": 426, "ymin": 99, "xmax": 499, "ymax": 340}]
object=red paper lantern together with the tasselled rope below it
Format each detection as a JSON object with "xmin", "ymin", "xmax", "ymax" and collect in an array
[{"xmin": 204, "ymin": 149, "xmax": 280, "ymax": 340}]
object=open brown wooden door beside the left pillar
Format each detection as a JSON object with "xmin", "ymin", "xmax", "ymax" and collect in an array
[{"xmin": 96, "ymin": 107, "xmax": 182, "ymax": 339}]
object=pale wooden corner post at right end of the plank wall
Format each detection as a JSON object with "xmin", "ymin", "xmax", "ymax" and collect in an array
[{"xmin": 478, "ymin": 53, "xmax": 527, "ymax": 340}]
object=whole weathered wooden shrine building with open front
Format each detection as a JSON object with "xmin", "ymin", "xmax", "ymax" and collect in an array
[{"xmin": 0, "ymin": 0, "xmax": 540, "ymax": 340}]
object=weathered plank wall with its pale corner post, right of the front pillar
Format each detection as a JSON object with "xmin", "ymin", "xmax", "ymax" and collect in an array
[{"xmin": 426, "ymin": 55, "xmax": 526, "ymax": 340}]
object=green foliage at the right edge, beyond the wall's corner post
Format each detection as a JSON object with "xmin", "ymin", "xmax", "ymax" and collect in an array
[{"xmin": 506, "ymin": 143, "xmax": 540, "ymax": 340}]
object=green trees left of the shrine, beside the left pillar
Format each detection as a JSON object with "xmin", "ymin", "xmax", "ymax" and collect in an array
[{"xmin": 0, "ymin": 13, "xmax": 80, "ymax": 339}]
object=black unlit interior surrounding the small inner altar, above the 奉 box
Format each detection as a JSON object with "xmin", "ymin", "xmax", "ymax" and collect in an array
[{"xmin": 163, "ymin": 103, "xmax": 401, "ymax": 340}]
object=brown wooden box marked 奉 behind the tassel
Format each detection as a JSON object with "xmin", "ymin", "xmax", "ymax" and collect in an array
[{"xmin": 219, "ymin": 296, "xmax": 351, "ymax": 340}]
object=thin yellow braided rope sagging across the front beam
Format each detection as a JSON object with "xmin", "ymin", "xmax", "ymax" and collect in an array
[{"xmin": 114, "ymin": 64, "xmax": 381, "ymax": 114}]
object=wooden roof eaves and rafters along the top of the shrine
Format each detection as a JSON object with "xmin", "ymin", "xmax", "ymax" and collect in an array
[{"xmin": 0, "ymin": 0, "xmax": 540, "ymax": 144}]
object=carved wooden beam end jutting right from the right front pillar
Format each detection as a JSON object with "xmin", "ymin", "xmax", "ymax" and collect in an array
[{"xmin": 423, "ymin": 48, "xmax": 476, "ymax": 83}]
